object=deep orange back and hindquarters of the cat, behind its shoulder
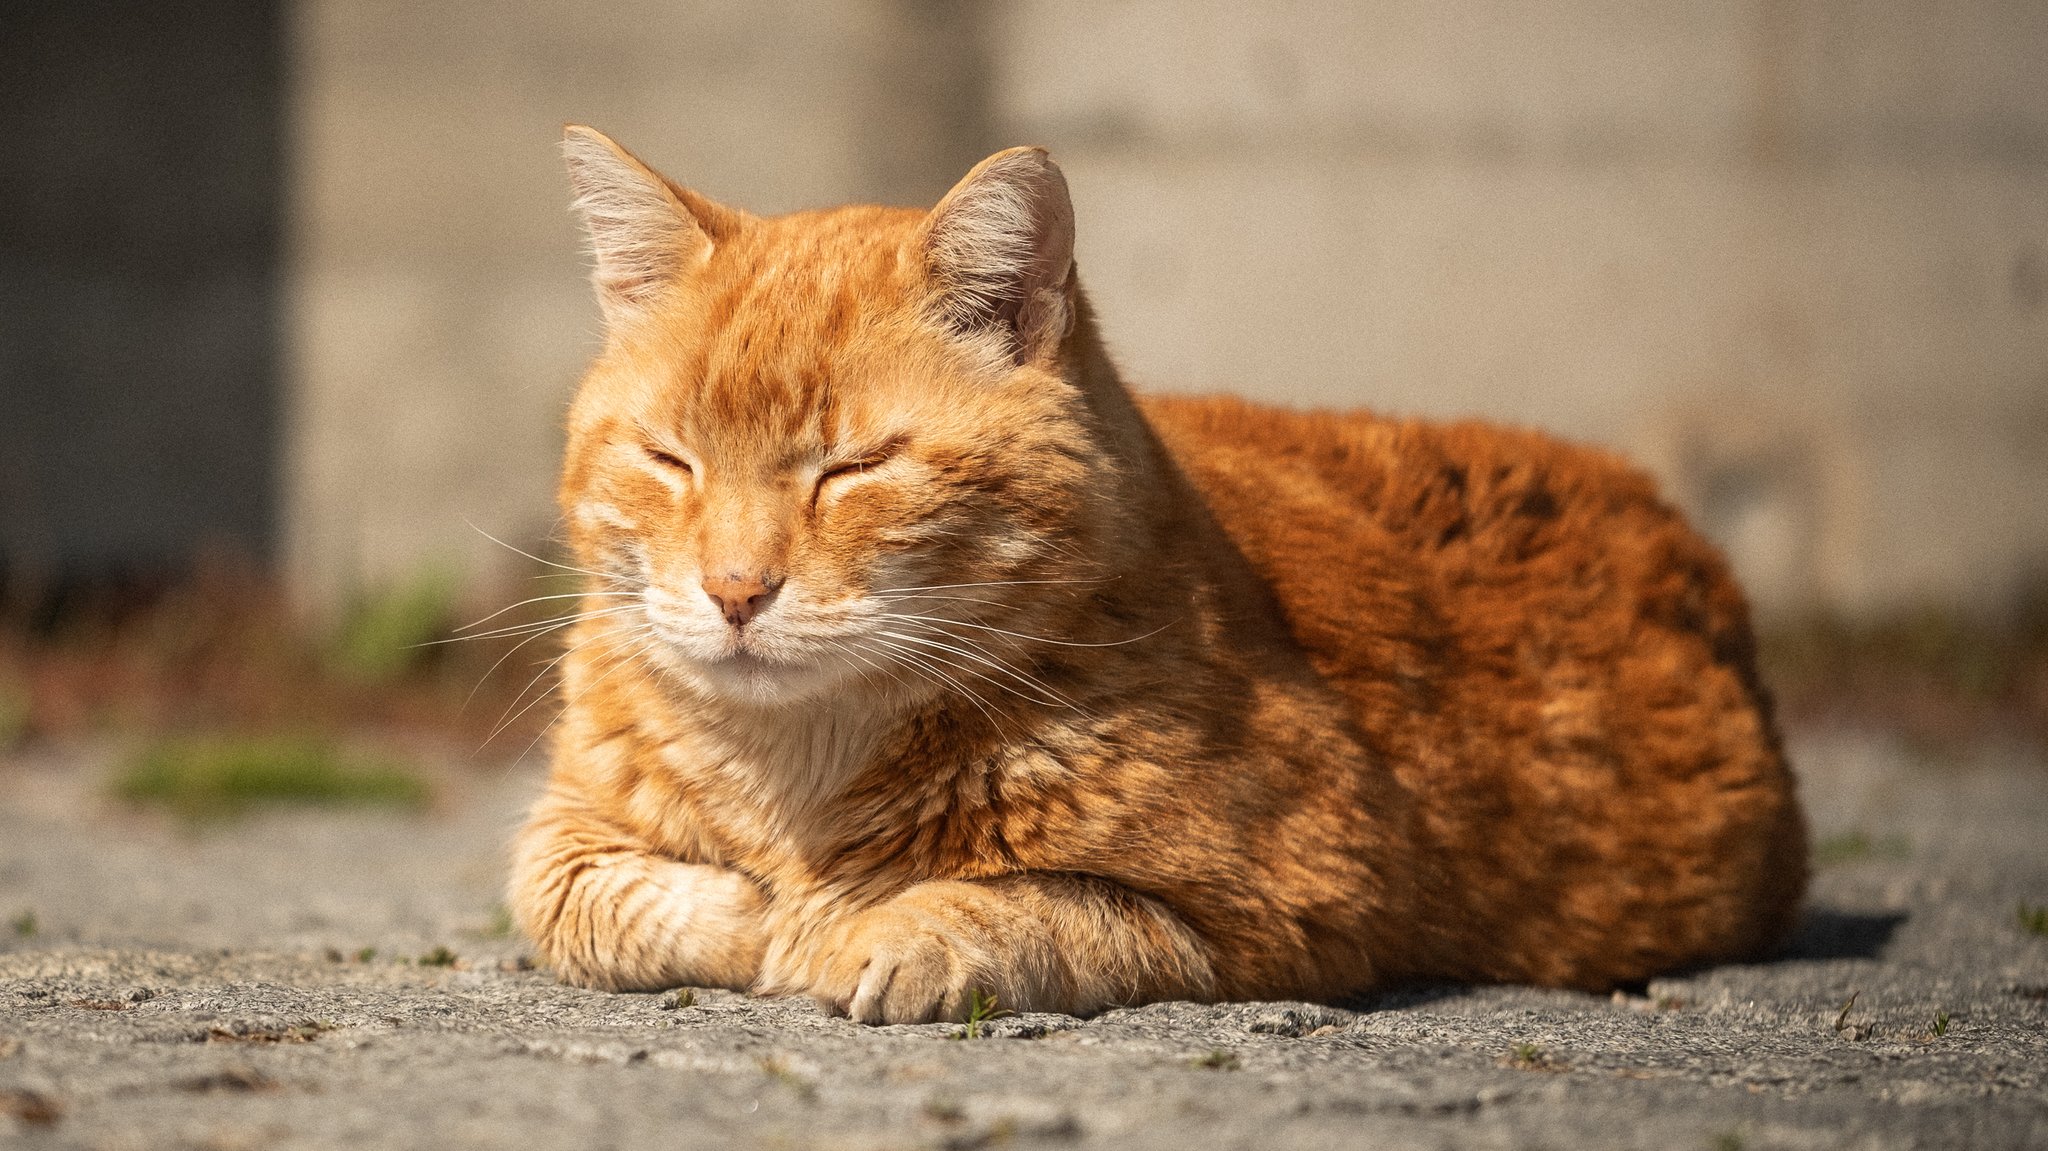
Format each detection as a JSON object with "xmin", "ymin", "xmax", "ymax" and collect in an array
[{"xmin": 1141, "ymin": 397, "xmax": 1804, "ymax": 985}]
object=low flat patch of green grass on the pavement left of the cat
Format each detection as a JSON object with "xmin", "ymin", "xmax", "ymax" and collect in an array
[{"xmin": 115, "ymin": 737, "xmax": 428, "ymax": 819}]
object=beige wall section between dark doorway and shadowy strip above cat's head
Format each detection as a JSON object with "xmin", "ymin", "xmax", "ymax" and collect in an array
[{"xmin": 285, "ymin": 0, "xmax": 991, "ymax": 602}]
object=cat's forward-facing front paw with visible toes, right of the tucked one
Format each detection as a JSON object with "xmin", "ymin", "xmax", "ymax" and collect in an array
[{"xmin": 811, "ymin": 901, "xmax": 999, "ymax": 1024}]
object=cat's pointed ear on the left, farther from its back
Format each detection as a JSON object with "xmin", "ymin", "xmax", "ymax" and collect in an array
[{"xmin": 561, "ymin": 125, "xmax": 735, "ymax": 324}]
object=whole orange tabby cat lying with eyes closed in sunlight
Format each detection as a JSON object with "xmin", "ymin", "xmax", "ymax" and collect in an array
[{"xmin": 510, "ymin": 127, "xmax": 1806, "ymax": 1022}]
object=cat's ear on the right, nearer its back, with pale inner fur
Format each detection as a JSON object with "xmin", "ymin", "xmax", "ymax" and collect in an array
[{"xmin": 922, "ymin": 147, "xmax": 1073, "ymax": 365}]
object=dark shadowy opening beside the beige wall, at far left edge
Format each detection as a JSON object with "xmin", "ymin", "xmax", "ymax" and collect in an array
[{"xmin": 0, "ymin": 0, "xmax": 285, "ymax": 586}]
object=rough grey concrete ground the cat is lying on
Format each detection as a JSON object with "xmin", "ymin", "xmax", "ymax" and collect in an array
[{"xmin": 0, "ymin": 733, "xmax": 2048, "ymax": 1151}]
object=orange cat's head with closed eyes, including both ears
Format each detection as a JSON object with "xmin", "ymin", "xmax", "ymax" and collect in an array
[{"xmin": 561, "ymin": 127, "xmax": 1114, "ymax": 705}]
